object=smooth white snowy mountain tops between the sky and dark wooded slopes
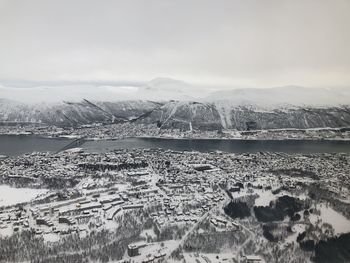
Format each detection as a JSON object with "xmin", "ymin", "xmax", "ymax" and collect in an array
[{"xmin": 0, "ymin": 78, "xmax": 350, "ymax": 107}]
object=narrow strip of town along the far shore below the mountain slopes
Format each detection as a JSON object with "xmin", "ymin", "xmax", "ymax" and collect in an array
[{"xmin": 0, "ymin": 122, "xmax": 350, "ymax": 140}]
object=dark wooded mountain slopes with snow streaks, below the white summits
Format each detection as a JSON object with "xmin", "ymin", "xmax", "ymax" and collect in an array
[{"xmin": 0, "ymin": 100, "xmax": 350, "ymax": 130}]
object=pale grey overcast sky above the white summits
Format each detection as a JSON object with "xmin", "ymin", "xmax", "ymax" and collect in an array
[{"xmin": 0, "ymin": 0, "xmax": 350, "ymax": 91}]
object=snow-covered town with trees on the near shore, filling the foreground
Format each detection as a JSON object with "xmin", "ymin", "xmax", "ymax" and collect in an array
[{"xmin": 0, "ymin": 148, "xmax": 350, "ymax": 262}]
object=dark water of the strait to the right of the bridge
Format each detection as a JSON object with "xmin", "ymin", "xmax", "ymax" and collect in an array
[{"xmin": 83, "ymin": 138, "xmax": 350, "ymax": 153}]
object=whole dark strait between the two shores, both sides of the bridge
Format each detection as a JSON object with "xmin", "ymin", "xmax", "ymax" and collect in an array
[{"xmin": 0, "ymin": 135, "xmax": 350, "ymax": 156}]
